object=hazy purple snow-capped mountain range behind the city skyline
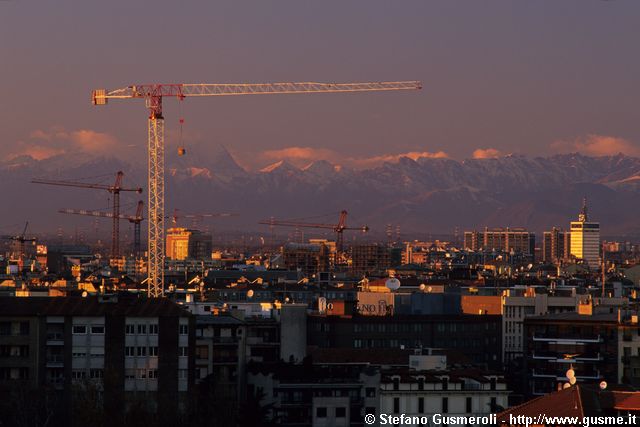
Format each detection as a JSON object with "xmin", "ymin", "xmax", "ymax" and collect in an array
[{"xmin": 7, "ymin": 147, "xmax": 640, "ymax": 238}]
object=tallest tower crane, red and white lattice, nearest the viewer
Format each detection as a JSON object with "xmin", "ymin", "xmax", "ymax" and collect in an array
[{"xmin": 91, "ymin": 81, "xmax": 422, "ymax": 297}]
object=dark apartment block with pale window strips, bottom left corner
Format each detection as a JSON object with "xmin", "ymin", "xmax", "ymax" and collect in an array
[{"xmin": 0, "ymin": 295, "xmax": 195, "ymax": 426}]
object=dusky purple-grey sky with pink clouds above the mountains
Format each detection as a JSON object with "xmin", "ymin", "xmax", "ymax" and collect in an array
[{"xmin": 0, "ymin": 0, "xmax": 640, "ymax": 169}]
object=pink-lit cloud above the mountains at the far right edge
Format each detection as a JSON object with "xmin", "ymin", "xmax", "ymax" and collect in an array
[{"xmin": 550, "ymin": 134, "xmax": 640, "ymax": 156}]
